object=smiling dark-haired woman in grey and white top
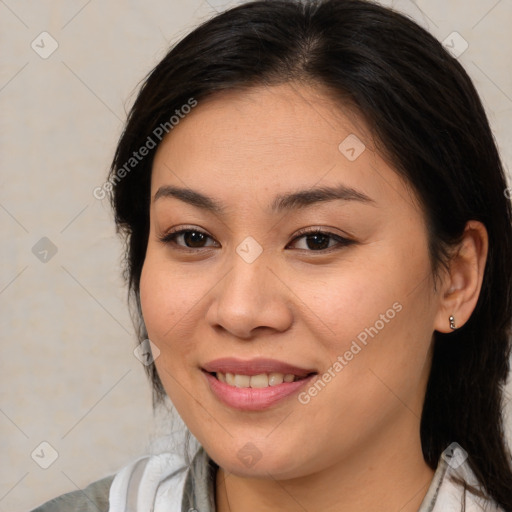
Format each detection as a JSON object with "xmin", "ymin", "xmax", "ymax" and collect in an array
[{"xmin": 31, "ymin": 0, "xmax": 512, "ymax": 512}]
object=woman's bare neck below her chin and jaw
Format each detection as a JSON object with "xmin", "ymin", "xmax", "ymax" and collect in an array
[{"xmin": 216, "ymin": 416, "xmax": 434, "ymax": 512}]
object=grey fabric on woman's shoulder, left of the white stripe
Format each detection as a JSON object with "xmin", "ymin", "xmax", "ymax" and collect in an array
[{"xmin": 32, "ymin": 475, "xmax": 115, "ymax": 512}]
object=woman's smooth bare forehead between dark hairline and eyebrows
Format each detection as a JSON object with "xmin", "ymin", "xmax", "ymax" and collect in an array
[{"xmin": 151, "ymin": 84, "xmax": 420, "ymax": 216}]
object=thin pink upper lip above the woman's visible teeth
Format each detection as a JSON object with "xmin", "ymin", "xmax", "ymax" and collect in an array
[{"xmin": 203, "ymin": 357, "xmax": 316, "ymax": 377}]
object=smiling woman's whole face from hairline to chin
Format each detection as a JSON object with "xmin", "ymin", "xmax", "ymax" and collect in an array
[{"xmin": 140, "ymin": 84, "xmax": 448, "ymax": 478}]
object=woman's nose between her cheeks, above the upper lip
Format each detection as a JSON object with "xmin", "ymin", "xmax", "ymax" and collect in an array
[{"xmin": 206, "ymin": 248, "xmax": 293, "ymax": 339}]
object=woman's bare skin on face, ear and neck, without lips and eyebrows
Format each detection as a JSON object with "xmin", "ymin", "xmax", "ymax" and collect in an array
[{"xmin": 140, "ymin": 83, "xmax": 488, "ymax": 512}]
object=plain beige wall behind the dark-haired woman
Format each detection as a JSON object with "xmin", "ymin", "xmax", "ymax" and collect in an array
[{"xmin": 0, "ymin": 0, "xmax": 512, "ymax": 512}]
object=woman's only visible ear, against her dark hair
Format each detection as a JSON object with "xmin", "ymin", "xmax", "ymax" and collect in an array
[{"xmin": 434, "ymin": 220, "xmax": 489, "ymax": 332}]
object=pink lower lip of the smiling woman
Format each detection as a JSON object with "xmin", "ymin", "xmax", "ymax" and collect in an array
[{"xmin": 202, "ymin": 370, "xmax": 315, "ymax": 411}]
